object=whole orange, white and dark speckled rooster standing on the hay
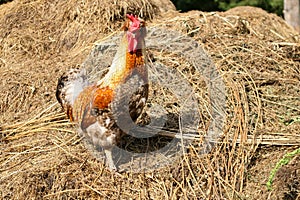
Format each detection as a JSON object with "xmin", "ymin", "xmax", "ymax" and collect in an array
[{"xmin": 56, "ymin": 14, "xmax": 148, "ymax": 170}]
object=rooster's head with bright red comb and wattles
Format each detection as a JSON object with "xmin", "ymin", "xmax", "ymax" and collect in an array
[{"xmin": 124, "ymin": 14, "xmax": 146, "ymax": 52}]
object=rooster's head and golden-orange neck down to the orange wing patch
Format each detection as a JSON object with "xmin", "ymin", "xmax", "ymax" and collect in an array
[{"xmin": 92, "ymin": 15, "xmax": 148, "ymax": 109}]
